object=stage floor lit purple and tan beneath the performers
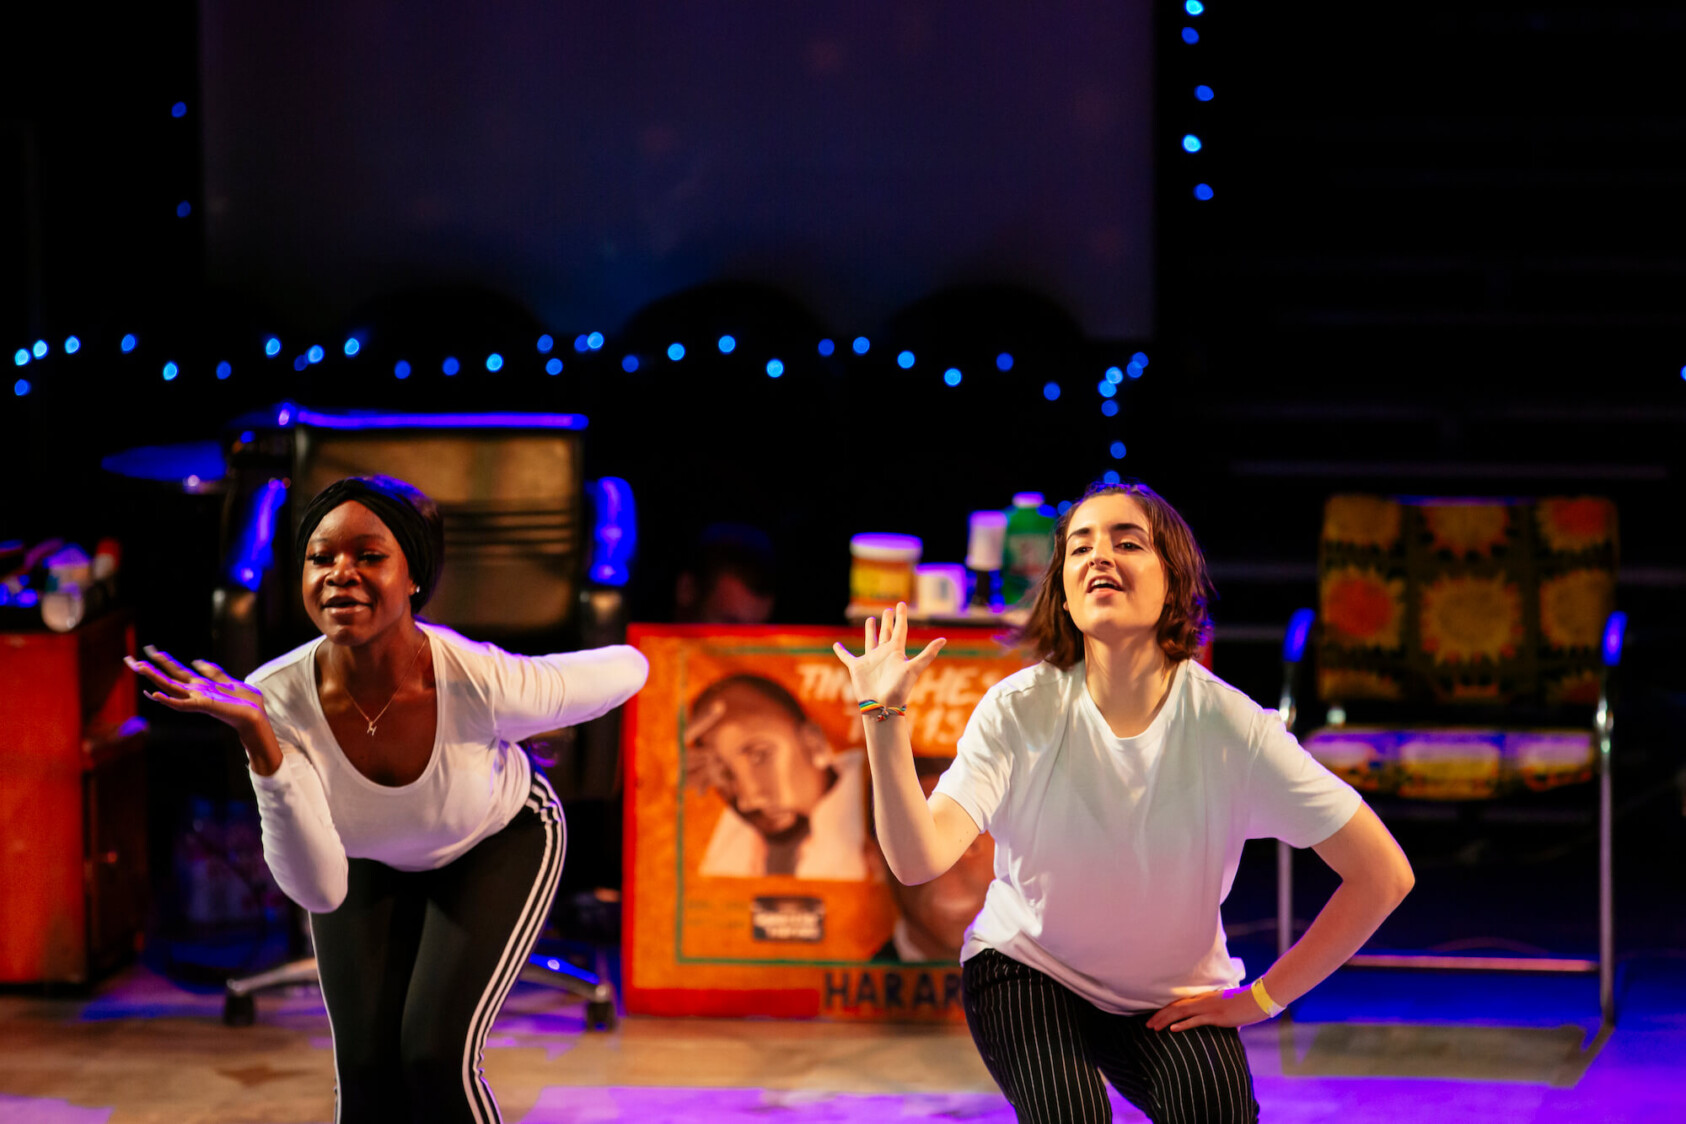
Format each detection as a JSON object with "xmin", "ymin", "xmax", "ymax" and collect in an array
[{"xmin": 0, "ymin": 957, "xmax": 1686, "ymax": 1124}]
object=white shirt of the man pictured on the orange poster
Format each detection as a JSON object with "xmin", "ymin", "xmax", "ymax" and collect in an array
[{"xmin": 698, "ymin": 750, "xmax": 867, "ymax": 881}]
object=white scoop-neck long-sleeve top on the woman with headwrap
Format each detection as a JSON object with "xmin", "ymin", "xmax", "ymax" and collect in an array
[{"xmin": 246, "ymin": 624, "xmax": 649, "ymax": 913}]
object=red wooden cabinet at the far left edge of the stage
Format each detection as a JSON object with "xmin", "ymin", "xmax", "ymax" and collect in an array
[{"xmin": 0, "ymin": 613, "xmax": 147, "ymax": 984}]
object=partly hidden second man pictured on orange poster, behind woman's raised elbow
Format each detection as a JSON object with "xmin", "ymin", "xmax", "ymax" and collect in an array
[{"xmin": 868, "ymin": 757, "xmax": 995, "ymax": 964}]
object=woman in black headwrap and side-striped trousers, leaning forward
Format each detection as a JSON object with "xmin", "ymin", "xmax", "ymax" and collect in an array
[{"xmin": 128, "ymin": 477, "xmax": 649, "ymax": 1124}]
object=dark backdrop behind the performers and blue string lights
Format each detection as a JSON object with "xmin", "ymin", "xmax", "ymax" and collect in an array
[{"xmin": 0, "ymin": 0, "xmax": 1686, "ymax": 970}]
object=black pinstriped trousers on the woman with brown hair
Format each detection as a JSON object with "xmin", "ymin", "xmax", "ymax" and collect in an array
[{"xmin": 961, "ymin": 949, "xmax": 1259, "ymax": 1124}]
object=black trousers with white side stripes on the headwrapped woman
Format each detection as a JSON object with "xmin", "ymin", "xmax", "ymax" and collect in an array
[{"xmin": 310, "ymin": 770, "xmax": 566, "ymax": 1124}]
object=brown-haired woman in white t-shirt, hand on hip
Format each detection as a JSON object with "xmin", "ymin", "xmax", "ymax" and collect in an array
[{"xmin": 836, "ymin": 484, "xmax": 1413, "ymax": 1122}]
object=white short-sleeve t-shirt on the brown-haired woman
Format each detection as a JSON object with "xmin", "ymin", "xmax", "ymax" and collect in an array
[{"xmin": 936, "ymin": 661, "xmax": 1361, "ymax": 1013}]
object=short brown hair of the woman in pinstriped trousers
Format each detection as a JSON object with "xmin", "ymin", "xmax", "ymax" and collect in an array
[{"xmin": 1013, "ymin": 480, "xmax": 1216, "ymax": 671}]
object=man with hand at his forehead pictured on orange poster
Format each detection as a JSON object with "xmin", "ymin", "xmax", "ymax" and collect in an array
[{"xmin": 685, "ymin": 674, "xmax": 868, "ymax": 881}]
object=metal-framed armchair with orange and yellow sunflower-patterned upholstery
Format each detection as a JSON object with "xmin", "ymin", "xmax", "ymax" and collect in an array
[{"xmin": 1278, "ymin": 495, "xmax": 1625, "ymax": 1023}]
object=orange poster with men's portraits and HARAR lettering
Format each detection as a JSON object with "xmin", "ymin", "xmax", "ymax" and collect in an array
[{"xmin": 622, "ymin": 625, "xmax": 1025, "ymax": 1021}]
